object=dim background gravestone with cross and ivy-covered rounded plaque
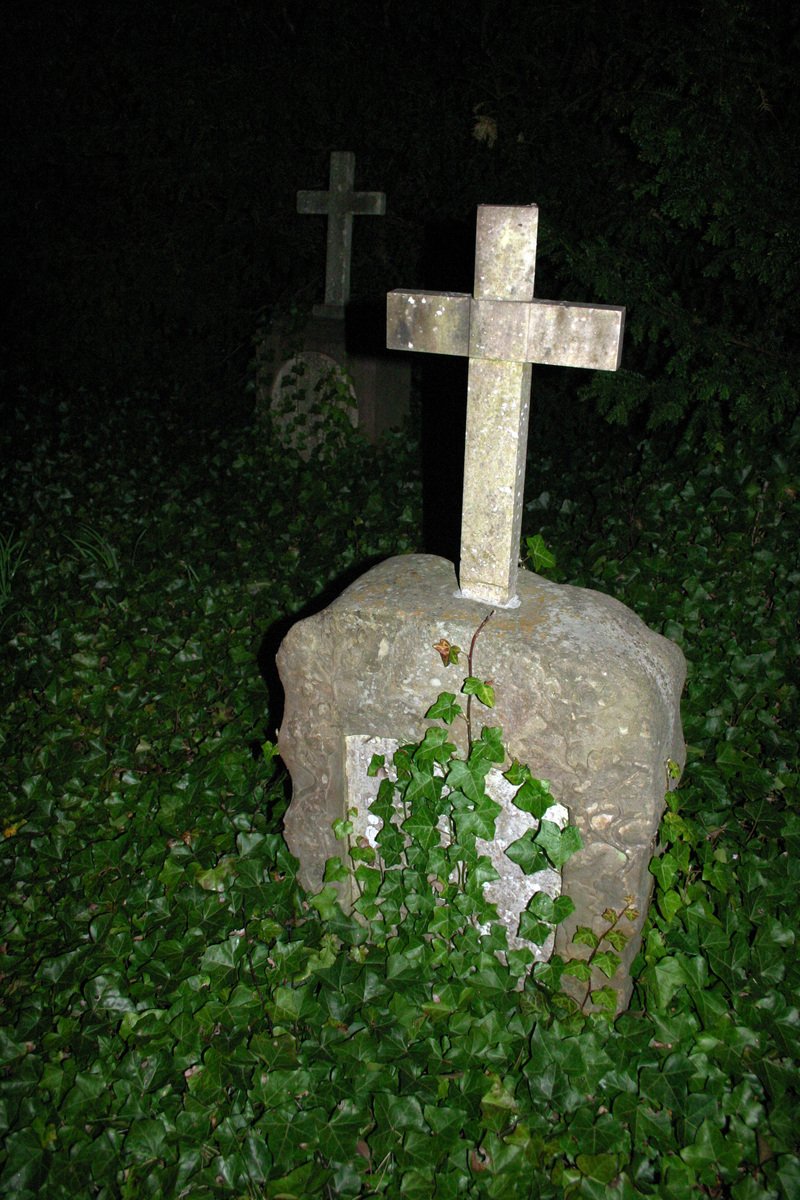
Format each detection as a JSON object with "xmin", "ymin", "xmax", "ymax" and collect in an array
[{"xmin": 255, "ymin": 151, "xmax": 410, "ymax": 452}]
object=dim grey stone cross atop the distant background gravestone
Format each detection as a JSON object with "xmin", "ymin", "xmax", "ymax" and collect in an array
[{"xmin": 297, "ymin": 150, "xmax": 386, "ymax": 319}]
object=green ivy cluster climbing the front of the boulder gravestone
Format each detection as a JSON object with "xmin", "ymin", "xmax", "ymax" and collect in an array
[{"xmin": 331, "ymin": 672, "xmax": 581, "ymax": 960}]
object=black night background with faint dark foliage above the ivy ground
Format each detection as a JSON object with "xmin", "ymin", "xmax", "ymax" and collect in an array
[{"xmin": 0, "ymin": 0, "xmax": 800, "ymax": 436}]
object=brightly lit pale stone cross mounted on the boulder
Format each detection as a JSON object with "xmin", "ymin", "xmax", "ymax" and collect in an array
[{"xmin": 386, "ymin": 204, "xmax": 625, "ymax": 608}]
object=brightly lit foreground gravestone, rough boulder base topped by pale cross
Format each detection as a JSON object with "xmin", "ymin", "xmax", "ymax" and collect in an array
[{"xmin": 278, "ymin": 205, "xmax": 685, "ymax": 1009}]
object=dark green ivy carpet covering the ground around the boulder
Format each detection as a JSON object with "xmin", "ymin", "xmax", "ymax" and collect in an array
[{"xmin": 0, "ymin": 396, "xmax": 800, "ymax": 1200}]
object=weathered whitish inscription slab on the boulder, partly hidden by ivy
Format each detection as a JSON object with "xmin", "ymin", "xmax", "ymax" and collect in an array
[{"xmin": 344, "ymin": 734, "xmax": 569, "ymax": 961}]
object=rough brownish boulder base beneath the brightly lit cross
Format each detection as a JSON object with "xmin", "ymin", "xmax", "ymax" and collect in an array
[{"xmin": 277, "ymin": 554, "xmax": 685, "ymax": 1008}]
